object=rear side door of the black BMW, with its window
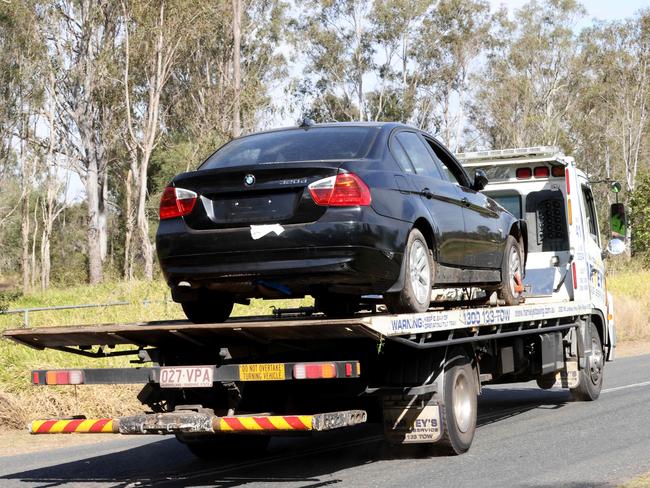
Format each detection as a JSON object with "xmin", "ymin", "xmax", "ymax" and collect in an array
[{"xmin": 390, "ymin": 130, "xmax": 467, "ymax": 266}]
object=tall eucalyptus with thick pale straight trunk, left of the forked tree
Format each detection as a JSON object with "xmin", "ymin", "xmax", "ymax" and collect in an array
[{"xmin": 37, "ymin": 0, "xmax": 120, "ymax": 283}]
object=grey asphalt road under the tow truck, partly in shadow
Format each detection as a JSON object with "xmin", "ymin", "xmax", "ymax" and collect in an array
[{"xmin": 0, "ymin": 355, "xmax": 650, "ymax": 488}]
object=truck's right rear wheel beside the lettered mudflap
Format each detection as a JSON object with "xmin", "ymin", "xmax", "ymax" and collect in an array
[{"xmin": 439, "ymin": 351, "xmax": 478, "ymax": 454}]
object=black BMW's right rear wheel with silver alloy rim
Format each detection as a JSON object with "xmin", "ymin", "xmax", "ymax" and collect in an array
[{"xmin": 384, "ymin": 229, "xmax": 433, "ymax": 313}]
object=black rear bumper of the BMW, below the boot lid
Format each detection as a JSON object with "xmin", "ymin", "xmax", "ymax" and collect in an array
[{"xmin": 157, "ymin": 209, "xmax": 410, "ymax": 300}]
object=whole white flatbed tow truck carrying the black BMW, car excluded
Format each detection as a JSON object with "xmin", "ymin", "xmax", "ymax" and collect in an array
[{"xmin": 4, "ymin": 146, "xmax": 624, "ymax": 457}]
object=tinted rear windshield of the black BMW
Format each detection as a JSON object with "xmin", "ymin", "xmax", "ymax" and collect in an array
[{"xmin": 200, "ymin": 127, "xmax": 378, "ymax": 169}]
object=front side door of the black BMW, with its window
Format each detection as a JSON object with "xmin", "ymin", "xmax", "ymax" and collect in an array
[{"xmin": 427, "ymin": 138, "xmax": 502, "ymax": 269}]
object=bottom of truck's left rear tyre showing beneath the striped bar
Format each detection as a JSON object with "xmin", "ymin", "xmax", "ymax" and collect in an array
[{"xmin": 176, "ymin": 434, "xmax": 271, "ymax": 460}]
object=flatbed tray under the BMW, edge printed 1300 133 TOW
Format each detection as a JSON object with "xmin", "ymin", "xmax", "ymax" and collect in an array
[{"xmin": 3, "ymin": 302, "xmax": 592, "ymax": 349}]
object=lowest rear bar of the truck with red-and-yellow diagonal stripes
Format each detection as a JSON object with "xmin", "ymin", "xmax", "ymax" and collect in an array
[{"xmin": 29, "ymin": 410, "xmax": 367, "ymax": 435}]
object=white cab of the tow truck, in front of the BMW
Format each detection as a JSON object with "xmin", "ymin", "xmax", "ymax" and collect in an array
[{"xmin": 458, "ymin": 146, "xmax": 616, "ymax": 360}]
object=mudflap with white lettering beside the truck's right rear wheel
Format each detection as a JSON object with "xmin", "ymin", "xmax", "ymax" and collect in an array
[{"xmin": 383, "ymin": 395, "xmax": 442, "ymax": 444}]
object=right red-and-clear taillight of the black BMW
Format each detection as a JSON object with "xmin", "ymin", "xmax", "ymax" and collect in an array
[{"xmin": 307, "ymin": 173, "xmax": 371, "ymax": 207}]
